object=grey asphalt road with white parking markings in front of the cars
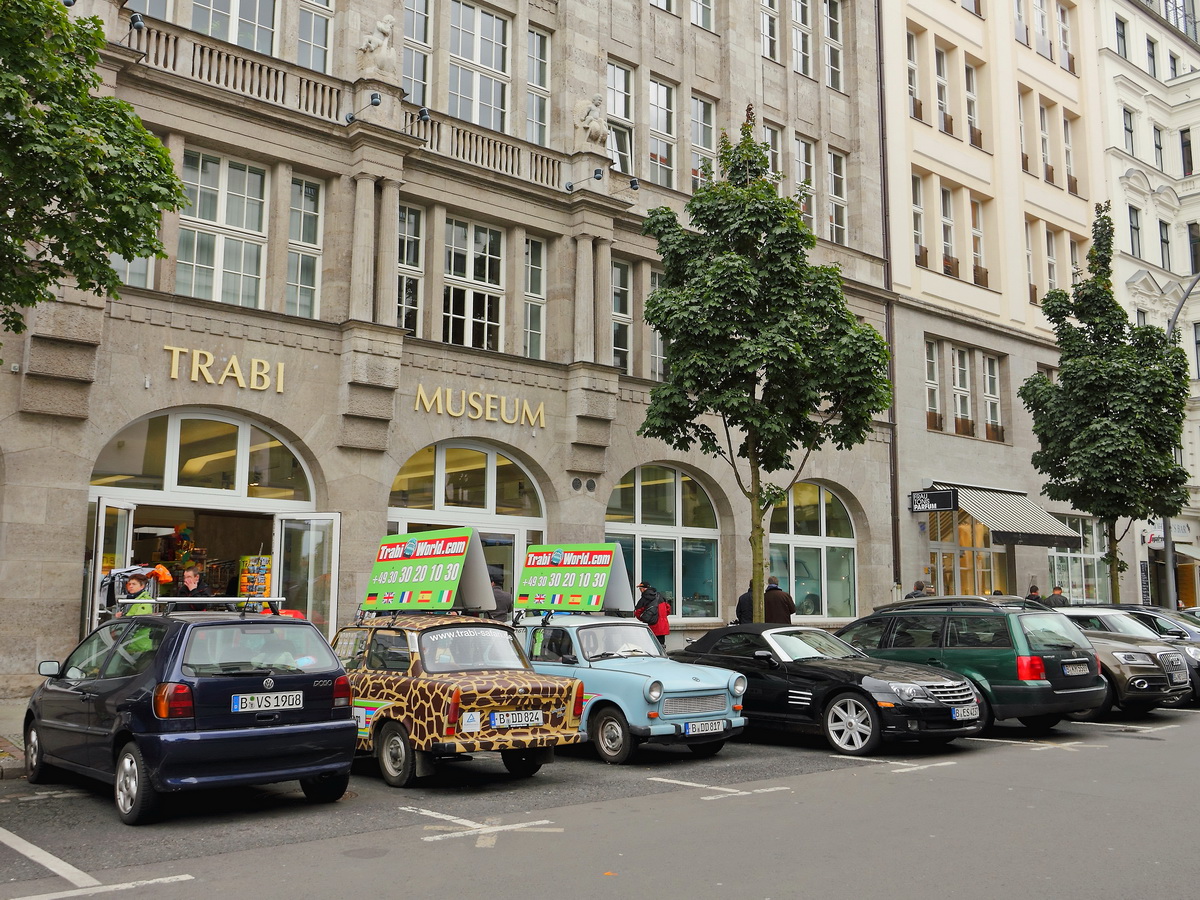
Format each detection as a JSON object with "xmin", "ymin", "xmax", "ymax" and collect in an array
[{"xmin": 0, "ymin": 709, "xmax": 1200, "ymax": 900}]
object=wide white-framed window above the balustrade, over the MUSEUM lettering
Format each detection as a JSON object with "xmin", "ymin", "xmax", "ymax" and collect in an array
[{"xmin": 449, "ymin": 0, "xmax": 509, "ymax": 131}]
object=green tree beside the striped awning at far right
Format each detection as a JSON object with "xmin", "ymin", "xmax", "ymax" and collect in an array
[{"xmin": 1018, "ymin": 203, "xmax": 1188, "ymax": 602}]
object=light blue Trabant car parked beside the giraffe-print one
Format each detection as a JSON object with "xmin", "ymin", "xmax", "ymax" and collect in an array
[{"xmin": 517, "ymin": 613, "xmax": 746, "ymax": 764}]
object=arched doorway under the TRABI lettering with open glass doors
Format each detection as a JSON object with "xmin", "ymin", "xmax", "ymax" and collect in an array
[{"xmin": 84, "ymin": 409, "xmax": 340, "ymax": 628}]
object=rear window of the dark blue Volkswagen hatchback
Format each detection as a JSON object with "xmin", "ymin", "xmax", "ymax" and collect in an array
[{"xmin": 182, "ymin": 622, "xmax": 338, "ymax": 676}]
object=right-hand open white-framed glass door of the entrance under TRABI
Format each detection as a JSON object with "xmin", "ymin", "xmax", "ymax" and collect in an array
[{"xmin": 271, "ymin": 512, "xmax": 340, "ymax": 636}]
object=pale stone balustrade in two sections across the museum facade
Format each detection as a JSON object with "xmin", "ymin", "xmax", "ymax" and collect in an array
[{"xmin": 132, "ymin": 22, "xmax": 563, "ymax": 188}]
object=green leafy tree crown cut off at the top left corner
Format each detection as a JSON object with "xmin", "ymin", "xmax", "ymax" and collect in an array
[{"xmin": 0, "ymin": 0, "xmax": 185, "ymax": 357}]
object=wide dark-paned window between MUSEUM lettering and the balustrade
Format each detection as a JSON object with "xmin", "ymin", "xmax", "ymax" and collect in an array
[{"xmin": 442, "ymin": 218, "xmax": 504, "ymax": 350}]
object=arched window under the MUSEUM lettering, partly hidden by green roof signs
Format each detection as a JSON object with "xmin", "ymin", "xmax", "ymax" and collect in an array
[{"xmin": 388, "ymin": 442, "xmax": 546, "ymax": 590}]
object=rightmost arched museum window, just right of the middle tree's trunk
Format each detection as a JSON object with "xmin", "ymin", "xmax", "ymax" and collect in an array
[{"xmin": 770, "ymin": 481, "xmax": 858, "ymax": 618}]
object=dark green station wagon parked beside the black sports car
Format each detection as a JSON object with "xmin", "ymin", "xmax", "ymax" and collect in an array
[{"xmin": 838, "ymin": 596, "xmax": 1105, "ymax": 732}]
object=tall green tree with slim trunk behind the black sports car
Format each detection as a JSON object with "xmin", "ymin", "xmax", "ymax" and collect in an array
[{"xmin": 638, "ymin": 108, "xmax": 892, "ymax": 622}]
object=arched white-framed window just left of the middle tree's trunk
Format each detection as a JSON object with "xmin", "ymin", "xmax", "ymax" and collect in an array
[{"xmin": 605, "ymin": 466, "xmax": 720, "ymax": 618}]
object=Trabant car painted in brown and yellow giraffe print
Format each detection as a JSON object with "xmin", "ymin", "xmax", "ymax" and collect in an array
[{"xmin": 334, "ymin": 613, "xmax": 587, "ymax": 755}]
